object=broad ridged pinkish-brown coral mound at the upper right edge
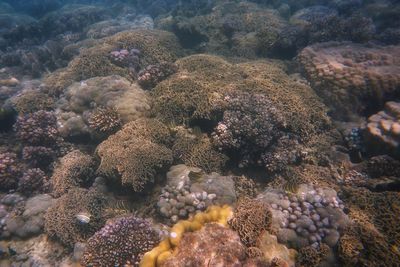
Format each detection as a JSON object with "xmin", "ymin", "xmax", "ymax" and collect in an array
[{"xmin": 298, "ymin": 42, "xmax": 400, "ymax": 117}]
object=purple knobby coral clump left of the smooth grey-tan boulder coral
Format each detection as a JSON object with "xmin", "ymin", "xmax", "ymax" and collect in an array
[{"xmin": 14, "ymin": 110, "xmax": 59, "ymax": 146}]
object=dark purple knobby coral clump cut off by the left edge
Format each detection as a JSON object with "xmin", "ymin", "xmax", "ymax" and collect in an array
[{"xmin": 0, "ymin": 152, "xmax": 20, "ymax": 190}]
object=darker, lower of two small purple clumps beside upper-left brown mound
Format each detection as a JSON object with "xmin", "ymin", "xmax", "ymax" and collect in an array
[{"xmin": 138, "ymin": 62, "xmax": 178, "ymax": 90}]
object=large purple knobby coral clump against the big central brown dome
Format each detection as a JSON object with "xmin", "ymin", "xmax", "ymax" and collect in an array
[{"xmin": 212, "ymin": 93, "xmax": 286, "ymax": 166}]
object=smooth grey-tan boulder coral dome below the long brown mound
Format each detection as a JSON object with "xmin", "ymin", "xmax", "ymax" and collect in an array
[{"xmin": 57, "ymin": 75, "xmax": 150, "ymax": 137}]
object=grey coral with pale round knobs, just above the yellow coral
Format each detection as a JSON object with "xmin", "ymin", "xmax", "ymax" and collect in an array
[{"xmin": 157, "ymin": 165, "xmax": 236, "ymax": 223}]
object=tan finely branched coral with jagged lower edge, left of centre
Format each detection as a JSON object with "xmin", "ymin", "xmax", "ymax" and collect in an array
[{"xmin": 97, "ymin": 119, "xmax": 172, "ymax": 191}]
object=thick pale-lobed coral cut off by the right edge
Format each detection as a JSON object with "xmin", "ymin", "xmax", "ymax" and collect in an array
[{"xmin": 365, "ymin": 101, "xmax": 400, "ymax": 157}]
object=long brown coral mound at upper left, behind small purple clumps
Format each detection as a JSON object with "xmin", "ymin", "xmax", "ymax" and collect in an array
[{"xmin": 44, "ymin": 30, "xmax": 181, "ymax": 95}]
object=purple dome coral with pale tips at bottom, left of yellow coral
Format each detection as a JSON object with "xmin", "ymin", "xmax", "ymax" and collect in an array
[{"xmin": 81, "ymin": 216, "xmax": 159, "ymax": 267}]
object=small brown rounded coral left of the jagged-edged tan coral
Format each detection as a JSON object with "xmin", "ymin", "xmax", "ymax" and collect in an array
[{"xmin": 50, "ymin": 150, "xmax": 96, "ymax": 197}]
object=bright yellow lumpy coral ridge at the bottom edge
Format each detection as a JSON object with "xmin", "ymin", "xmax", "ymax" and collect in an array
[{"xmin": 139, "ymin": 205, "xmax": 232, "ymax": 267}]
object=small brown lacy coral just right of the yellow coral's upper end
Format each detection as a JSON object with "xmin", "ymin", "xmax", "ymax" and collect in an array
[{"xmin": 228, "ymin": 198, "xmax": 272, "ymax": 248}]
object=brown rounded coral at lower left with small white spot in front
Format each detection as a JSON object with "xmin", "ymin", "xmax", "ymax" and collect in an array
[{"xmin": 44, "ymin": 188, "xmax": 106, "ymax": 248}]
